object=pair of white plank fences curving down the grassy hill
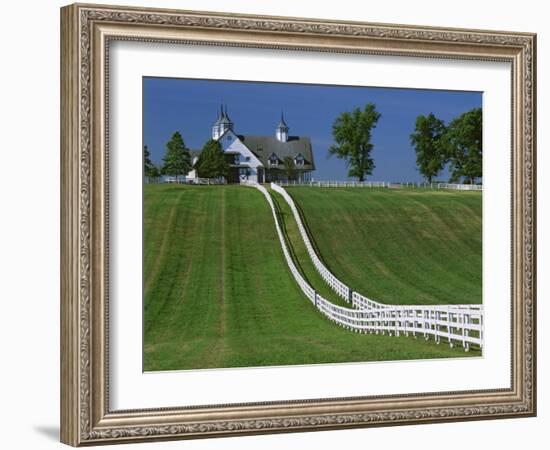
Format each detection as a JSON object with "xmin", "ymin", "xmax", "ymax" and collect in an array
[{"xmin": 243, "ymin": 182, "xmax": 483, "ymax": 351}]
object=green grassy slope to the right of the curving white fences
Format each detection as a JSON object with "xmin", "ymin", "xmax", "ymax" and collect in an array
[{"xmin": 287, "ymin": 187, "xmax": 482, "ymax": 304}]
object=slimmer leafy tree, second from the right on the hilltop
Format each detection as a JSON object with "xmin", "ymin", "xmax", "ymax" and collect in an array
[{"xmin": 410, "ymin": 113, "xmax": 446, "ymax": 183}]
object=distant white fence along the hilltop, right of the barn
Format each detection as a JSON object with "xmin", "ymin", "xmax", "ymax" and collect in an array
[{"xmin": 277, "ymin": 180, "xmax": 483, "ymax": 191}]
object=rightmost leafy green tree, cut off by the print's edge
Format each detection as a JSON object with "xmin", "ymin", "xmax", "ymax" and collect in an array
[{"xmin": 443, "ymin": 108, "xmax": 483, "ymax": 184}]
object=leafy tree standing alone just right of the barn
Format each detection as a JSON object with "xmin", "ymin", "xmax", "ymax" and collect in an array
[{"xmin": 328, "ymin": 103, "xmax": 380, "ymax": 181}]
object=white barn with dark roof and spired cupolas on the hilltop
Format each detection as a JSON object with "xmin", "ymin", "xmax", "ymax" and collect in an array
[{"xmin": 187, "ymin": 106, "xmax": 315, "ymax": 183}]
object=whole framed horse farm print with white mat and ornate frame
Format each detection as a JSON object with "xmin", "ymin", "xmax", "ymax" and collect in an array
[{"xmin": 61, "ymin": 4, "xmax": 536, "ymax": 446}]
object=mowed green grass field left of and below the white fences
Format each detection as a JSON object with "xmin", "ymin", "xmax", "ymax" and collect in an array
[{"xmin": 143, "ymin": 185, "xmax": 479, "ymax": 371}]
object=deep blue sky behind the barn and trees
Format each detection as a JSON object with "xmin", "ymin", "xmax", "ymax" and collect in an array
[{"xmin": 143, "ymin": 77, "xmax": 482, "ymax": 181}]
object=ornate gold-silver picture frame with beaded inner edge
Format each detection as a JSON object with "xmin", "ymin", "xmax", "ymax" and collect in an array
[{"xmin": 61, "ymin": 4, "xmax": 536, "ymax": 446}]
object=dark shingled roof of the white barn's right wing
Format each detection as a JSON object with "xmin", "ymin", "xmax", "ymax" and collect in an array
[{"xmin": 239, "ymin": 135, "xmax": 315, "ymax": 170}]
